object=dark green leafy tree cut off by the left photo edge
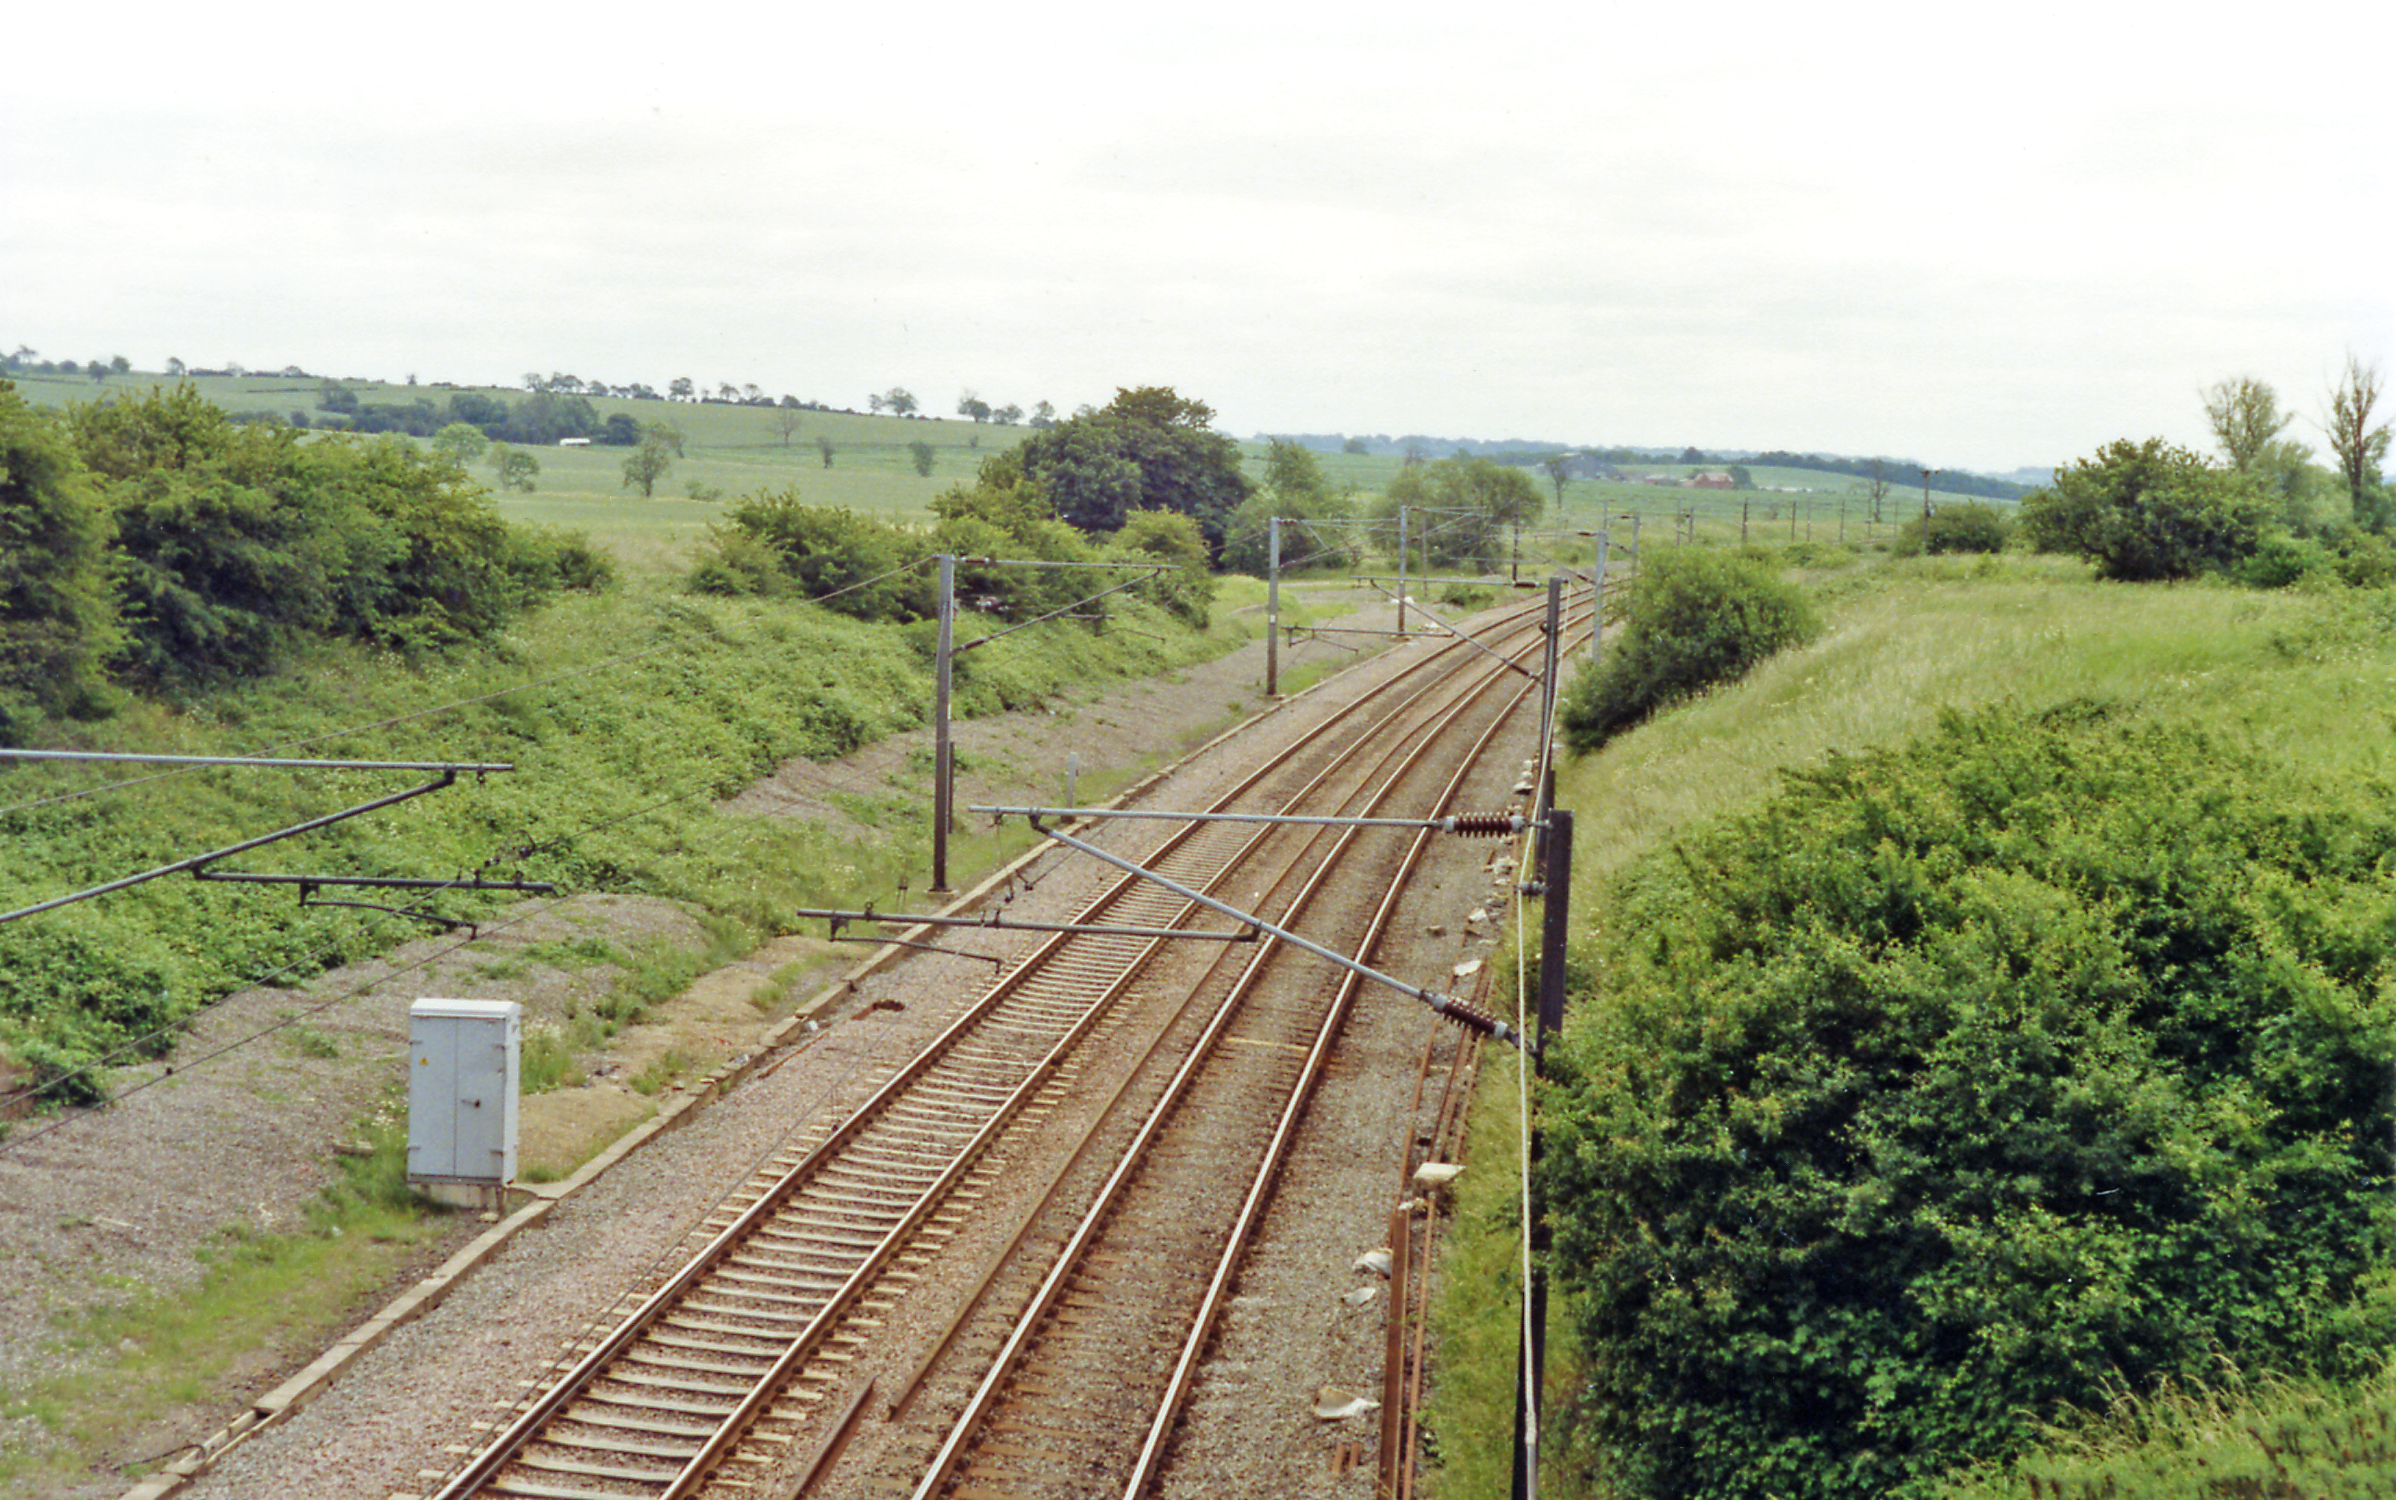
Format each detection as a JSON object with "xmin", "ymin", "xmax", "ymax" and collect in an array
[{"xmin": 0, "ymin": 381, "xmax": 125, "ymax": 728}]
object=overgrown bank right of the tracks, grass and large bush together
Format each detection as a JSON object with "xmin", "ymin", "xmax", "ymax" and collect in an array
[{"xmin": 1440, "ymin": 563, "xmax": 2396, "ymax": 1495}]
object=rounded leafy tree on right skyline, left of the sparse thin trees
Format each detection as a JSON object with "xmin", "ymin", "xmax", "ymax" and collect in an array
[{"xmin": 2022, "ymin": 438, "xmax": 2267, "ymax": 582}]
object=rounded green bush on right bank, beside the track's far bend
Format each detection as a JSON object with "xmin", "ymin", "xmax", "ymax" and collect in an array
[{"xmin": 1562, "ymin": 546, "xmax": 1821, "ymax": 750}]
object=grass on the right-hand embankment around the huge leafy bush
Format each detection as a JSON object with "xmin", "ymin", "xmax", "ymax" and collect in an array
[{"xmin": 1433, "ymin": 548, "xmax": 2396, "ymax": 1498}]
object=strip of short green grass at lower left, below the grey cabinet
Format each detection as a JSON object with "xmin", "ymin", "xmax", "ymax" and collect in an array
[{"xmin": 0, "ymin": 1126, "xmax": 448, "ymax": 1493}]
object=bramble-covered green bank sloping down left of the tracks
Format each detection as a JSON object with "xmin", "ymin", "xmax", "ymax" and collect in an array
[{"xmin": 0, "ymin": 580, "xmax": 1248, "ymax": 1100}]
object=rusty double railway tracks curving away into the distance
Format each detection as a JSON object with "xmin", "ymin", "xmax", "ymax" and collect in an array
[{"xmin": 424, "ymin": 584, "xmax": 1600, "ymax": 1500}]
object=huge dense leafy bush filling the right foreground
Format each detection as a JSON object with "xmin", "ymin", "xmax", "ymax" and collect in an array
[{"xmin": 1545, "ymin": 709, "xmax": 2396, "ymax": 1500}]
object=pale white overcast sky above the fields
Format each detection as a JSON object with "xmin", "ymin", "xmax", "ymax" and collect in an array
[{"xmin": 0, "ymin": 0, "xmax": 2396, "ymax": 470}]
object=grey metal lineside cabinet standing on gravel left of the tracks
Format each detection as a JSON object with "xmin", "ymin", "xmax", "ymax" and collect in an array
[{"xmin": 407, "ymin": 999, "xmax": 525, "ymax": 1188}]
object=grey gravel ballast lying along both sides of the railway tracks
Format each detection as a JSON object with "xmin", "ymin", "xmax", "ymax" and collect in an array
[{"xmin": 0, "ymin": 587, "xmax": 1543, "ymax": 1500}]
